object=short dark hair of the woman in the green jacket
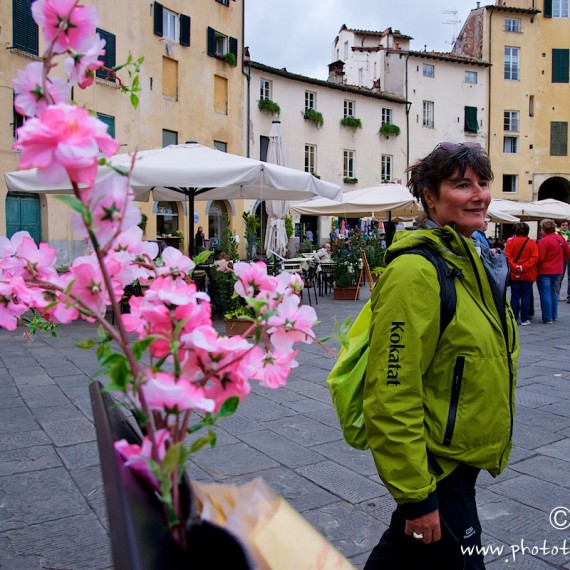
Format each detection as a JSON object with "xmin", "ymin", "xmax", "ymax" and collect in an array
[{"xmin": 407, "ymin": 143, "xmax": 493, "ymax": 212}]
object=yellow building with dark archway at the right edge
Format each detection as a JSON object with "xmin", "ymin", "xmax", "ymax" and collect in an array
[{"xmin": 454, "ymin": 0, "xmax": 570, "ymax": 202}]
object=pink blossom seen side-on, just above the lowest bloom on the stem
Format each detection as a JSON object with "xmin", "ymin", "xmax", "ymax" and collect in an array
[{"xmin": 141, "ymin": 372, "xmax": 214, "ymax": 414}]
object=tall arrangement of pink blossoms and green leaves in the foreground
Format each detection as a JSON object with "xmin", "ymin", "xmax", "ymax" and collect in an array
[{"xmin": 0, "ymin": 0, "xmax": 326, "ymax": 568}]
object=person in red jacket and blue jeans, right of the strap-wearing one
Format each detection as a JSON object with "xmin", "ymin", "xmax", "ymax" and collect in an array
[{"xmin": 536, "ymin": 219, "xmax": 570, "ymax": 325}]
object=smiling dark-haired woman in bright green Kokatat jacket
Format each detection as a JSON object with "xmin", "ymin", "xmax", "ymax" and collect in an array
[{"xmin": 364, "ymin": 143, "xmax": 518, "ymax": 570}]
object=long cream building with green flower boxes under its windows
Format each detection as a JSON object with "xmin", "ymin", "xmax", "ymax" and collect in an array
[{"xmin": 246, "ymin": 62, "xmax": 407, "ymax": 244}]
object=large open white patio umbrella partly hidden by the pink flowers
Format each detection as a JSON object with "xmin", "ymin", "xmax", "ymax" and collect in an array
[{"xmin": 4, "ymin": 143, "xmax": 342, "ymax": 251}]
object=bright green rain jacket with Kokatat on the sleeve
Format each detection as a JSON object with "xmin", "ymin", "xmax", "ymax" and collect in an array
[{"xmin": 364, "ymin": 226, "xmax": 519, "ymax": 519}]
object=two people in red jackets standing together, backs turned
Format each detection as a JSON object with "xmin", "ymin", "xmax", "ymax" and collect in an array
[{"xmin": 505, "ymin": 219, "xmax": 570, "ymax": 326}]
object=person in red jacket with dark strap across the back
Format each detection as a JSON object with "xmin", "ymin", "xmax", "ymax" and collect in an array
[{"xmin": 505, "ymin": 222, "xmax": 538, "ymax": 327}]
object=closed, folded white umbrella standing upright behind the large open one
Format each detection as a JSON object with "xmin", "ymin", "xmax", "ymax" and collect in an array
[{"xmin": 265, "ymin": 120, "xmax": 290, "ymax": 256}]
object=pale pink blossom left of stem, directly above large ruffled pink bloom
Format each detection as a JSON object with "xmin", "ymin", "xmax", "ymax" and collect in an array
[{"xmin": 12, "ymin": 61, "xmax": 71, "ymax": 117}]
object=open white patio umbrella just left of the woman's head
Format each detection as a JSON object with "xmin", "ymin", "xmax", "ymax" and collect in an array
[{"xmin": 291, "ymin": 184, "xmax": 422, "ymax": 220}]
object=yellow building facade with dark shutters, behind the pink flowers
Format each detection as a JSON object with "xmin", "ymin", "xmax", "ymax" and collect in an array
[{"xmin": 0, "ymin": 0, "xmax": 245, "ymax": 264}]
